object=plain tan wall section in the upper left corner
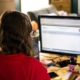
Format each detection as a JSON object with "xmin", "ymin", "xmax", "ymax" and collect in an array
[{"xmin": 0, "ymin": 0, "xmax": 15, "ymax": 15}]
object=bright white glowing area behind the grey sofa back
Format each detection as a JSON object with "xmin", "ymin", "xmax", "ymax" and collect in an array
[{"xmin": 21, "ymin": 0, "xmax": 49, "ymax": 13}]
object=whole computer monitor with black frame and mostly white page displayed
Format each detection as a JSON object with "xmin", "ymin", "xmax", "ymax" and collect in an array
[{"xmin": 38, "ymin": 16, "xmax": 80, "ymax": 55}]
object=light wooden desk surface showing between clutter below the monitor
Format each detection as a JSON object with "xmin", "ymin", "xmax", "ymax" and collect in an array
[{"xmin": 39, "ymin": 53, "xmax": 78, "ymax": 80}]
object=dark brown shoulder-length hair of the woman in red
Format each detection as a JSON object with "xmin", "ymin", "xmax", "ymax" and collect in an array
[{"xmin": 0, "ymin": 11, "xmax": 34, "ymax": 56}]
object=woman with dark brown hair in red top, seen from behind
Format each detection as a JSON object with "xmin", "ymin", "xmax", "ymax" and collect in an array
[{"xmin": 0, "ymin": 11, "xmax": 50, "ymax": 80}]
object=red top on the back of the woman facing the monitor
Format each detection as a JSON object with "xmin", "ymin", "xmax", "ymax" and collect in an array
[{"xmin": 0, "ymin": 53, "xmax": 50, "ymax": 80}]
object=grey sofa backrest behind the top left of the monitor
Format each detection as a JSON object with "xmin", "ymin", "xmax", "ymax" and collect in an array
[{"xmin": 27, "ymin": 5, "xmax": 57, "ymax": 22}]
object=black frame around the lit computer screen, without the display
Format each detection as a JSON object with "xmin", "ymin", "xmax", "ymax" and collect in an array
[{"xmin": 38, "ymin": 15, "xmax": 80, "ymax": 56}]
